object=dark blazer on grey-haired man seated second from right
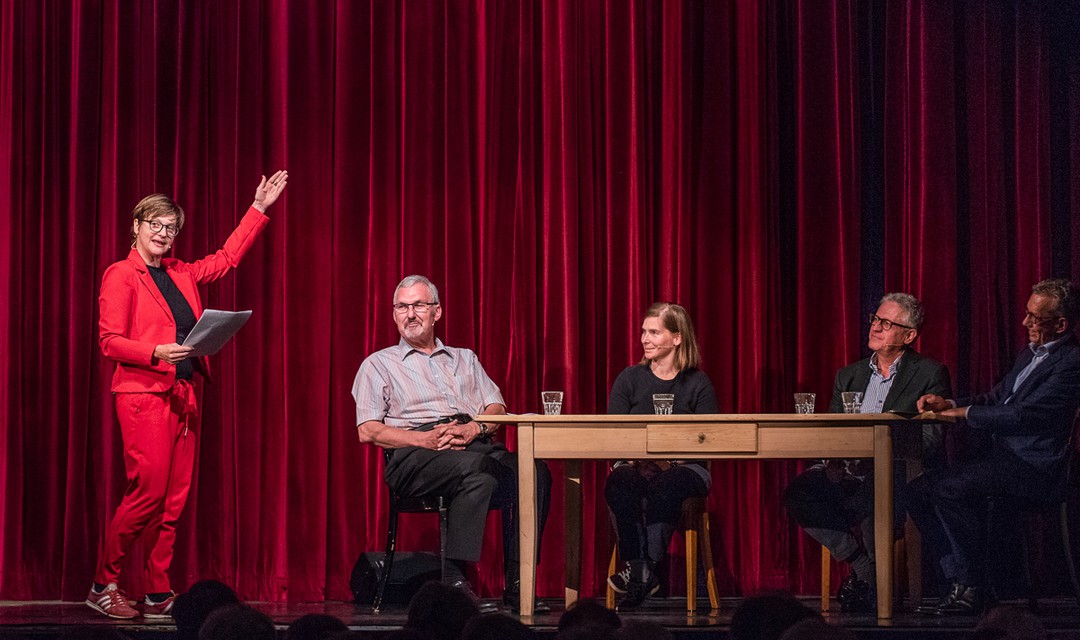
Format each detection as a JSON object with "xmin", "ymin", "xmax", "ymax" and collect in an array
[{"xmin": 828, "ymin": 349, "xmax": 953, "ymax": 462}]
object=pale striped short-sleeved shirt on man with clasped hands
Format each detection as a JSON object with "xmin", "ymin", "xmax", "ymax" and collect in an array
[{"xmin": 352, "ymin": 338, "xmax": 505, "ymax": 428}]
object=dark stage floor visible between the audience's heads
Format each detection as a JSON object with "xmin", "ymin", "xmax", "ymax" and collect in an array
[{"xmin": 0, "ymin": 598, "xmax": 1080, "ymax": 640}]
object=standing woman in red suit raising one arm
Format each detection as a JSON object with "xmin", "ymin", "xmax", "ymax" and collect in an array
[{"xmin": 86, "ymin": 171, "xmax": 288, "ymax": 618}]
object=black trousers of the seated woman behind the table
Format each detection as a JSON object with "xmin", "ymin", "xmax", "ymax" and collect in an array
[{"xmin": 604, "ymin": 464, "xmax": 708, "ymax": 562}]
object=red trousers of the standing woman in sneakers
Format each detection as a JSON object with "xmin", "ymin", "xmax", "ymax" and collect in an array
[{"xmin": 94, "ymin": 380, "xmax": 199, "ymax": 594}]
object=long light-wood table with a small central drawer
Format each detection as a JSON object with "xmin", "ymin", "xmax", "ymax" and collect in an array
[{"xmin": 484, "ymin": 413, "xmax": 948, "ymax": 618}]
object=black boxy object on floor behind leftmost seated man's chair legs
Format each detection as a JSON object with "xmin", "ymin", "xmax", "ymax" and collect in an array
[{"xmin": 349, "ymin": 552, "xmax": 442, "ymax": 604}]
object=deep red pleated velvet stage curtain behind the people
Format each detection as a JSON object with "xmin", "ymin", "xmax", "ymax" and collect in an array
[{"xmin": 0, "ymin": 0, "xmax": 1080, "ymax": 600}]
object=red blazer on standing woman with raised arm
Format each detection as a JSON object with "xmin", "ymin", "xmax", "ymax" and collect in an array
[{"xmin": 97, "ymin": 207, "xmax": 270, "ymax": 393}]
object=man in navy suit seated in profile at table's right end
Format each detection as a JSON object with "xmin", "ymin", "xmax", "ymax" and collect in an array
[{"xmin": 910, "ymin": 280, "xmax": 1080, "ymax": 615}]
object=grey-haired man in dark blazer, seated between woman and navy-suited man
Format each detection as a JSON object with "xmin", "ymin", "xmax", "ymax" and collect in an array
[{"xmin": 784, "ymin": 294, "xmax": 951, "ymax": 613}]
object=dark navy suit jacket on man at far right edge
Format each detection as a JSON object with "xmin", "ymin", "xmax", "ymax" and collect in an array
[{"xmin": 957, "ymin": 336, "xmax": 1080, "ymax": 498}]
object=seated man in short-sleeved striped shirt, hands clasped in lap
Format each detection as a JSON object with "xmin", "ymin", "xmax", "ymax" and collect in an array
[{"xmin": 352, "ymin": 275, "xmax": 551, "ymax": 610}]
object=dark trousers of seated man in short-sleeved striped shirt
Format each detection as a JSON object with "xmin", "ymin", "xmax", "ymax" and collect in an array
[{"xmin": 386, "ymin": 439, "xmax": 551, "ymax": 578}]
